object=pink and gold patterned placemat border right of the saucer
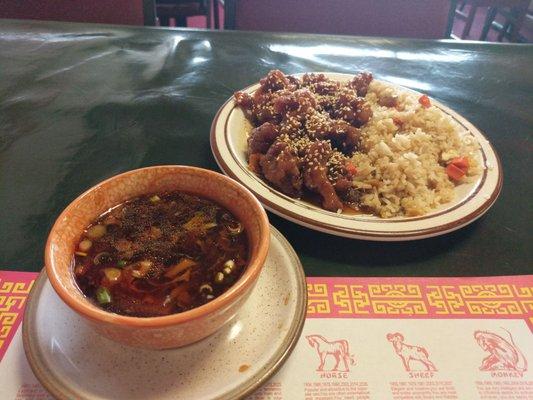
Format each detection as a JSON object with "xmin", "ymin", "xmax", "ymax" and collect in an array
[{"xmin": 307, "ymin": 275, "xmax": 533, "ymax": 331}]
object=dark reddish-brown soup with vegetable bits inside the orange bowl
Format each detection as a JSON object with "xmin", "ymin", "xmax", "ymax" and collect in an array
[{"xmin": 74, "ymin": 192, "xmax": 248, "ymax": 317}]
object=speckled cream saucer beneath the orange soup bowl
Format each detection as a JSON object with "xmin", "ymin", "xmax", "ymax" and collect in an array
[{"xmin": 23, "ymin": 228, "xmax": 307, "ymax": 400}]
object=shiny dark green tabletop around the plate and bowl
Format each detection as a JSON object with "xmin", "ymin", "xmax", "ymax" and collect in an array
[{"xmin": 0, "ymin": 20, "xmax": 533, "ymax": 276}]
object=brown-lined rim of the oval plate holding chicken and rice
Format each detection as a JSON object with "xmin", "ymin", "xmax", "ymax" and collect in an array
[{"xmin": 209, "ymin": 71, "xmax": 503, "ymax": 241}]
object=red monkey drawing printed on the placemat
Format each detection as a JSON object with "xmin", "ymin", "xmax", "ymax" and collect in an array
[{"xmin": 474, "ymin": 328, "xmax": 527, "ymax": 372}]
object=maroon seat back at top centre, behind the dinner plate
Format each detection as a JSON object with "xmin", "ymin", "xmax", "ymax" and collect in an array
[{"xmin": 235, "ymin": 0, "xmax": 450, "ymax": 38}]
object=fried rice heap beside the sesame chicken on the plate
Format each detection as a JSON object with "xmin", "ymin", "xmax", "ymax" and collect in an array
[{"xmin": 352, "ymin": 80, "xmax": 483, "ymax": 218}]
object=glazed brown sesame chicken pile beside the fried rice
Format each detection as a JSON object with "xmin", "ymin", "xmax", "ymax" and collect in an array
[{"xmin": 234, "ymin": 70, "xmax": 372, "ymax": 212}]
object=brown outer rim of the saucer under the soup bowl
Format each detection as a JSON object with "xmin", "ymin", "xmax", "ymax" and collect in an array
[{"xmin": 22, "ymin": 225, "xmax": 307, "ymax": 400}]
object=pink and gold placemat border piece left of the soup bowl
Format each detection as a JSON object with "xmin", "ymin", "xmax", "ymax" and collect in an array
[{"xmin": 0, "ymin": 271, "xmax": 38, "ymax": 361}]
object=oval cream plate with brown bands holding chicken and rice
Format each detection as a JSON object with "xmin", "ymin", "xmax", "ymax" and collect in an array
[{"xmin": 210, "ymin": 73, "xmax": 502, "ymax": 241}]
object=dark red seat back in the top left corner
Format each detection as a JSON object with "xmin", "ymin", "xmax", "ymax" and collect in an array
[{"xmin": 0, "ymin": 0, "xmax": 144, "ymax": 25}]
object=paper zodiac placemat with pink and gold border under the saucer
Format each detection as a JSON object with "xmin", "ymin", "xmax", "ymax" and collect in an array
[{"xmin": 0, "ymin": 271, "xmax": 533, "ymax": 400}]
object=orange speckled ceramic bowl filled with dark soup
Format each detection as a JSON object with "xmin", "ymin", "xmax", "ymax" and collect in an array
[{"xmin": 45, "ymin": 166, "xmax": 270, "ymax": 349}]
